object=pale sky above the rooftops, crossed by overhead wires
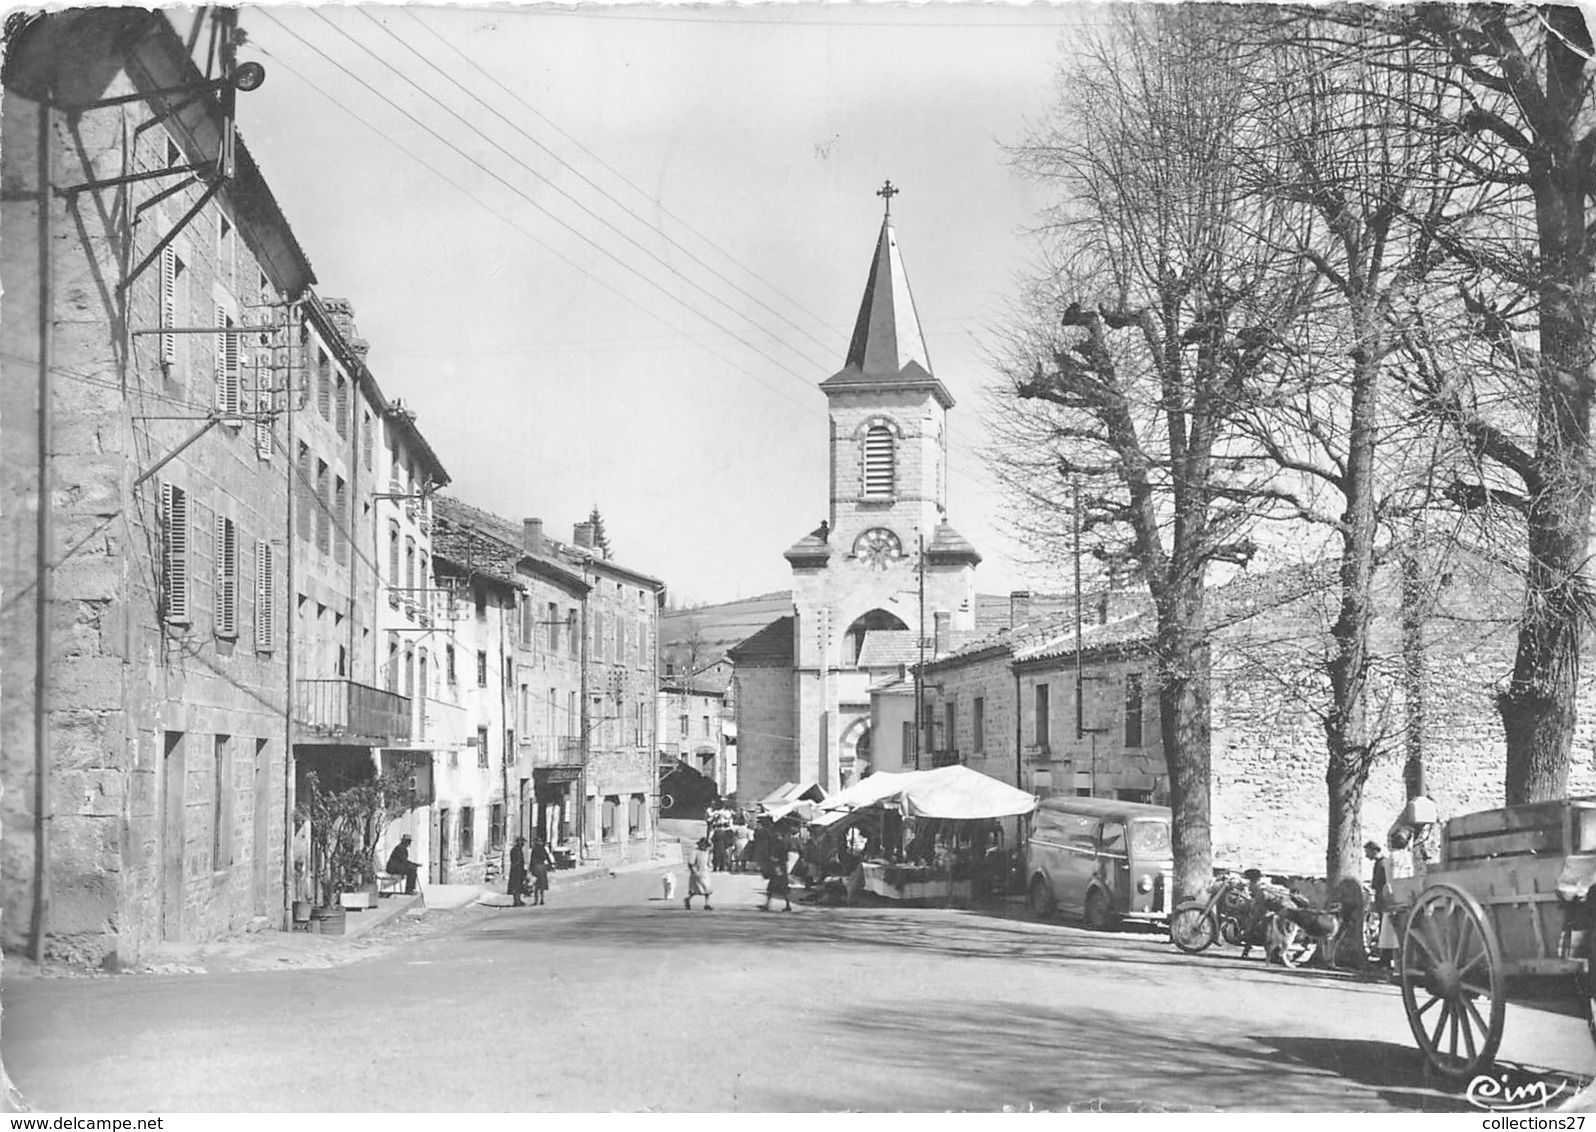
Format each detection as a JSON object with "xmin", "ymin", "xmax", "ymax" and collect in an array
[{"xmin": 233, "ymin": 3, "xmax": 1103, "ymax": 604}]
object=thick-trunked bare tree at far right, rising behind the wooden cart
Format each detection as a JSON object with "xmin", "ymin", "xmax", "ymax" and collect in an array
[{"xmin": 1328, "ymin": 5, "xmax": 1596, "ymax": 803}]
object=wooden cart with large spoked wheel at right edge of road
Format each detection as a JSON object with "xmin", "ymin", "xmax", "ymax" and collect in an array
[{"xmin": 1392, "ymin": 795, "xmax": 1596, "ymax": 1081}]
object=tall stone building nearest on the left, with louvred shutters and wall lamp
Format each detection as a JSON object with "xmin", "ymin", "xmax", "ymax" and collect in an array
[{"xmin": 0, "ymin": 8, "xmax": 314, "ymax": 966}]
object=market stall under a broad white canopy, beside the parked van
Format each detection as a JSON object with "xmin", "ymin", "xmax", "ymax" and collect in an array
[{"xmin": 811, "ymin": 766, "xmax": 1036, "ymax": 902}]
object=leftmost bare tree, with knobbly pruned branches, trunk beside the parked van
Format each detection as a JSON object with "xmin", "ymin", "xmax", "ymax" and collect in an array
[{"xmin": 994, "ymin": 6, "xmax": 1304, "ymax": 893}]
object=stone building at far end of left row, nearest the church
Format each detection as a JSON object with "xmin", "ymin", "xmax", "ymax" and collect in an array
[{"xmin": 436, "ymin": 497, "xmax": 664, "ymax": 864}]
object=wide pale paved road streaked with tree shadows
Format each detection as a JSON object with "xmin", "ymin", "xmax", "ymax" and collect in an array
[{"xmin": 0, "ymin": 873, "xmax": 1596, "ymax": 1111}]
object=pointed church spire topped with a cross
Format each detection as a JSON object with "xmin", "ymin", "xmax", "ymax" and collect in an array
[{"xmin": 820, "ymin": 180, "xmax": 953, "ymax": 409}]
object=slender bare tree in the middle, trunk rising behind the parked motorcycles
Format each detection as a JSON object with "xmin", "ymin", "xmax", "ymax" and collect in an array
[{"xmin": 1221, "ymin": 10, "xmax": 1459, "ymax": 881}]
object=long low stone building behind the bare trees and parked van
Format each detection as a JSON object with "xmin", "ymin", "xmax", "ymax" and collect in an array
[{"xmin": 922, "ymin": 549, "xmax": 1596, "ymax": 875}]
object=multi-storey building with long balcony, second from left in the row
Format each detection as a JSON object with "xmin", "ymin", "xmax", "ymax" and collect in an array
[{"xmin": 284, "ymin": 292, "xmax": 448, "ymax": 897}]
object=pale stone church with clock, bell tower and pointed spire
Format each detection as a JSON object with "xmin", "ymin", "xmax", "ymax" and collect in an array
[{"xmin": 728, "ymin": 182, "xmax": 982, "ymax": 802}]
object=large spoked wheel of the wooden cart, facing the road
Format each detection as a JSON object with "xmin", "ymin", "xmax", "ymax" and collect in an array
[{"xmin": 1401, "ymin": 885, "xmax": 1507, "ymax": 1081}]
